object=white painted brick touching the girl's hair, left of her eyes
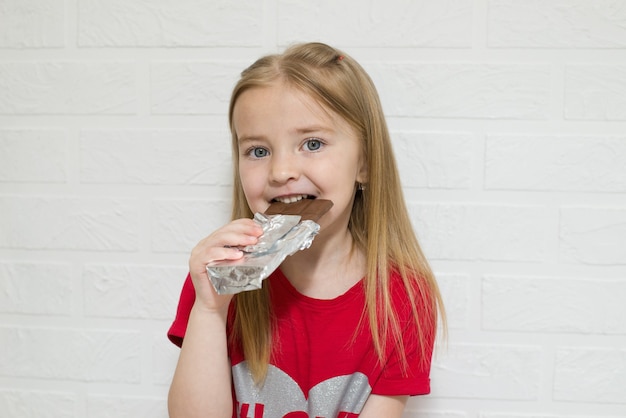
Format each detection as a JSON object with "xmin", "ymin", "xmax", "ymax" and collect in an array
[{"xmin": 80, "ymin": 130, "xmax": 232, "ymax": 186}]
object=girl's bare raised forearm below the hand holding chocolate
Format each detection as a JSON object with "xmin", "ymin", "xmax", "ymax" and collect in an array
[{"xmin": 168, "ymin": 304, "xmax": 233, "ymax": 418}]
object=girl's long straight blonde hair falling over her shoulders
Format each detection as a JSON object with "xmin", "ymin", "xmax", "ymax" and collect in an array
[{"xmin": 229, "ymin": 43, "xmax": 445, "ymax": 382}]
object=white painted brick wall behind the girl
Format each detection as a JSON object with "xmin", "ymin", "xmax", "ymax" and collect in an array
[{"xmin": 0, "ymin": 0, "xmax": 626, "ymax": 418}]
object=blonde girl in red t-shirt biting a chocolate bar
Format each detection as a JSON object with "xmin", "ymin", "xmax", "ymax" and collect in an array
[{"xmin": 169, "ymin": 43, "xmax": 442, "ymax": 418}]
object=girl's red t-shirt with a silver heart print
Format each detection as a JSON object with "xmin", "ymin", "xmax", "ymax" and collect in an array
[{"xmin": 168, "ymin": 269, "xmax": 434, "ymax": 418}]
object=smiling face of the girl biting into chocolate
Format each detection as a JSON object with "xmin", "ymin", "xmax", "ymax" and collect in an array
[{"xmin": 233, "ymin": 83, "xmax": 367, "ymax": 237}]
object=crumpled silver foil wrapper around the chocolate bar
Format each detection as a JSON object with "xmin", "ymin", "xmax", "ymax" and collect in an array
[{"xmin": 206, "ymin": 213, "xmax": 320, "ymax": 295}]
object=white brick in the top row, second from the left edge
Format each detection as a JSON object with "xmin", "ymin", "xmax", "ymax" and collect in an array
[{"xmin": 78, "ymin": 0, "xmax": 262, "ymax": 47}]
